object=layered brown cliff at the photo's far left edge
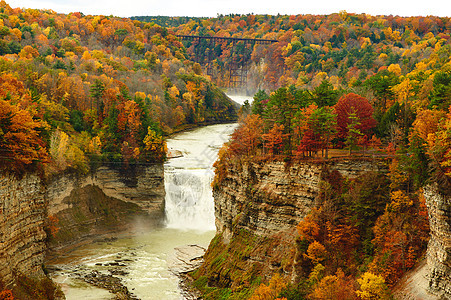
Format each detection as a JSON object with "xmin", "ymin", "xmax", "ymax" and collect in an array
[{"xmin": 0, "ymin": 174, "xmax": 47, "ymax": 286}]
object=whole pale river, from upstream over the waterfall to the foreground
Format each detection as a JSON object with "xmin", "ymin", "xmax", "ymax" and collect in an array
[{"xmin": 48, "ymin": 97, "xmax": 251, "ymax": 300}]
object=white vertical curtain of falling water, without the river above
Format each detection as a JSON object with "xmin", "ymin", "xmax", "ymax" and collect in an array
[{"xmin": 164, "ymin": 168, "xmax": 215, "ymax": 231}]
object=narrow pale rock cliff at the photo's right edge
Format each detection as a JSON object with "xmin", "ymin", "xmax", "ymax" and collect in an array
[{"xmin": 424, "ymin": 186, "xmax": 451, "ymax": 299}]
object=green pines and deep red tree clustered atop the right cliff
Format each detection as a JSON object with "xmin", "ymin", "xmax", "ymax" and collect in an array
[{"xmin": 219, "ymin": 86, "xmax": 378, "ymax": 163}]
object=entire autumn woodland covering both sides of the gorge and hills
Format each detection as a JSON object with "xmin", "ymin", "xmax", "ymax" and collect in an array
[{"xmin": 0, "ymin": 1, "xmax": 451, "ymax": 299}]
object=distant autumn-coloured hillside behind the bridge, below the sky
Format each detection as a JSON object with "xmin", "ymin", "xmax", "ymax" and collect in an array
[{"xmin": 139, "ymin": 11, "xmax": 451, "ymax": 90}]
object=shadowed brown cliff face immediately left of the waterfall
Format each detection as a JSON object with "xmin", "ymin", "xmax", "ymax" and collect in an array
[{"xmin": 46, "ymin": 164, "xmax": 165, "ymax": 248}]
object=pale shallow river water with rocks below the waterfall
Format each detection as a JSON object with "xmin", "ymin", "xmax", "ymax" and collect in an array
[{"xmin": 49, "ymin": 228, "xmax": 214, "ymax": 300}]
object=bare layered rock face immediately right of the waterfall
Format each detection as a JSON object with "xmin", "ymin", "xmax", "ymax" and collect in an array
[{"xmin": 214, "ymin": 160, "xmax": 387, "ymax": 242}]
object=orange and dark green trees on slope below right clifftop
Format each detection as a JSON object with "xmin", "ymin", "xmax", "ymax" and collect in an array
[{"xmin": 297, "ymin": 164, "xmax": 429, "ymax": 299}]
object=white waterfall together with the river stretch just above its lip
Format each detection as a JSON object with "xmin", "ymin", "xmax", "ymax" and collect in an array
[{"xmin": 164, "ymin": 124, "xmax": 237, "ymax": 231}]
